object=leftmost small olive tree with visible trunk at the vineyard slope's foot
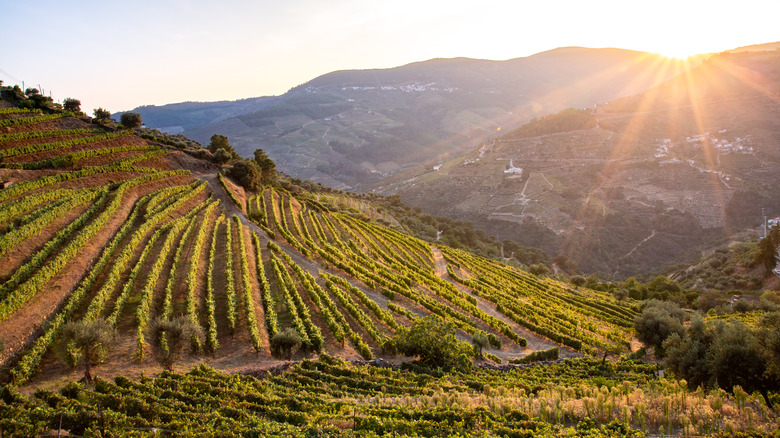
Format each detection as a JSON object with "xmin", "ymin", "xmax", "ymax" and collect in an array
[{"xmin": 58, "ymin": 319, "xmax": 116, "ymax": 382}]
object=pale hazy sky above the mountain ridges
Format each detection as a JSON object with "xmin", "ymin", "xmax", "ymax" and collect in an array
[{"xmin": 0, "ymin": 0, "xmax": 780, "ymax": 113}]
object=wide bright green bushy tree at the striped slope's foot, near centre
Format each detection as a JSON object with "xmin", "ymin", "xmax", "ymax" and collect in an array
[{"xmin": 394, "ymin": 314, "xmax": 472, "ymax": 369}]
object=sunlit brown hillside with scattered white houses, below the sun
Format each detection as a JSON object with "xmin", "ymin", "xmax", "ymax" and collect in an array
[{"xmin": 386, "ymin": 51, "xmax": 780, "ymax": 278}]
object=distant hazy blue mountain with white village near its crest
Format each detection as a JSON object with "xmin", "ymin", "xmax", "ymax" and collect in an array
[{"xmin": 125, "ymin": 47, "xmax": 686, "ymax": 190}]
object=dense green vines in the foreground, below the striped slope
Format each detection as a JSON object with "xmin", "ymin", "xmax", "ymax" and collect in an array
[{"xmin": 6, "ymin": 355, "xmax": 776, "ymax": 437}]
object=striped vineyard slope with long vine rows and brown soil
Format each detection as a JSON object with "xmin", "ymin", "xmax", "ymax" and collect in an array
[{"xmin": 0, "ymin": 99, "xmax": 636, "ymax": 390}]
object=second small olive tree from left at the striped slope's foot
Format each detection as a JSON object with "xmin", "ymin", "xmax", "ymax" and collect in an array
[{"xmin": 149, "ymin": 316, "xmax": 204, "ymax": 370}]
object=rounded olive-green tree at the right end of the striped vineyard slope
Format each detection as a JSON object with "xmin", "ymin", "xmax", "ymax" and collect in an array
[{"xmin": 634, "ymin": 300, "xmax": 685, "ymax": 349}]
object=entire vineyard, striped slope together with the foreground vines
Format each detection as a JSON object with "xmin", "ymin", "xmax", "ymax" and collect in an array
[{"xmin": 0, "ymin": 109, "xmax": 774, "ymax": 436}]
